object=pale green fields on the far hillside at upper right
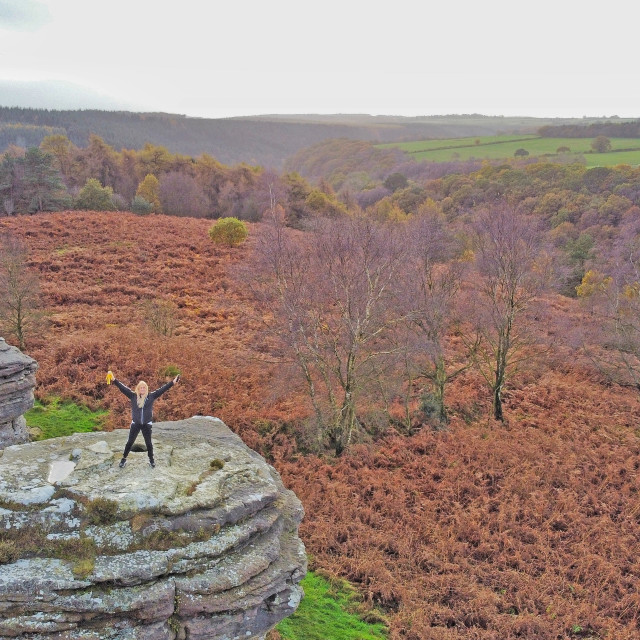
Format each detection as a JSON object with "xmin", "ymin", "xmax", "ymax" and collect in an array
[{"xmin": 377, "ymin": 135, "xmax": 640, "ymax": 167}]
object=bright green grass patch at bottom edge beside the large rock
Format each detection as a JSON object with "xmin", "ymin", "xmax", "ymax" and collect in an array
[{"xmin": 276, "ymin": 571, "xmax": 387, "ymax": 640}]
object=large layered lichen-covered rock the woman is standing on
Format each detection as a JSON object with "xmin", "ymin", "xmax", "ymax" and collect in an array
[{"xmin": 0, "ymin": 417, "xmax": 306, "ymax": 640}]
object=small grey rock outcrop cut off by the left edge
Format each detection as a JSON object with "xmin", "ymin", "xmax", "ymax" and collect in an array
[{"xmin": 0, "ymin": 338, "xmax": 38, "ymax": 449}]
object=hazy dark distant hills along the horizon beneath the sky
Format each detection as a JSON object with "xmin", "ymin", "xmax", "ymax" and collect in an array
[{"xmin": 0, "ymin": 106, "xmax": 623, "ymax": 169}]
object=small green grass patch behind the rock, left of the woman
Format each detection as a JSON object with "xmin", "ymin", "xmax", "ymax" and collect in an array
[{"xmin": 25, "ymin": 397, "xmax": 108, "ymax": 440}]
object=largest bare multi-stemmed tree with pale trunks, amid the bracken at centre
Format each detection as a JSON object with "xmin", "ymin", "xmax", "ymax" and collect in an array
[{"xmin": 255, "ymin": 212, "xmax": 406, "ymax": 454}]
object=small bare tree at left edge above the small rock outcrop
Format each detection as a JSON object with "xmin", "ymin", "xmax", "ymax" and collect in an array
[{"xmin": 0, "ymin": 235, "xmax": 43, "ymax": 350}]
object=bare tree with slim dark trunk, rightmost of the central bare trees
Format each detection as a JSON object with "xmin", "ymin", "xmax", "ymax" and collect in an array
[{"xmin": 473, "ymin": 203, "xmax": 549, "ymax": 421}]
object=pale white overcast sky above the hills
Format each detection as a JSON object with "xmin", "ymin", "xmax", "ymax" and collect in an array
[{"xmin": 0, "ymin": 0, "xmax": 640, "ymax": 117}]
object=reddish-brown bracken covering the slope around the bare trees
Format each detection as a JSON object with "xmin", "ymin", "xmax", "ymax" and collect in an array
[{"xmin": 0, "ymin": 212, "xmax": 640, "ymax": 640}]
